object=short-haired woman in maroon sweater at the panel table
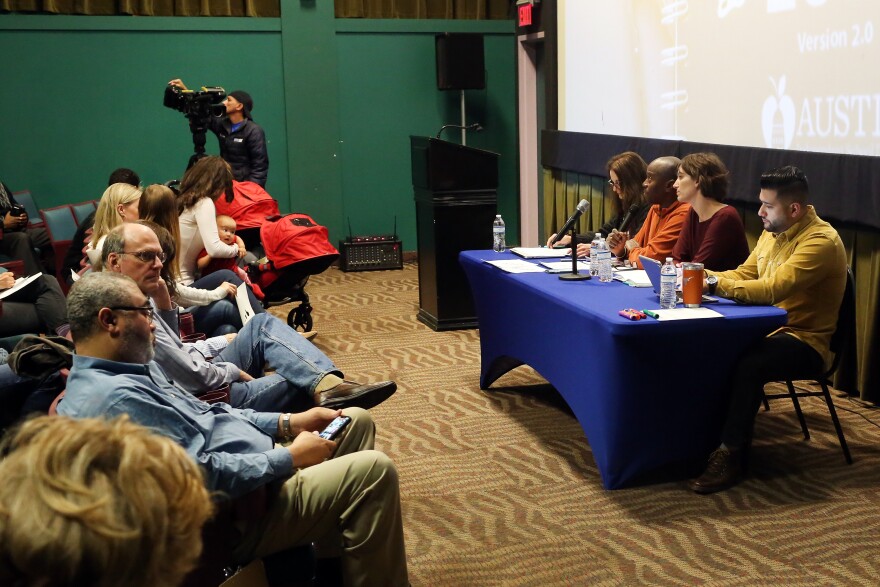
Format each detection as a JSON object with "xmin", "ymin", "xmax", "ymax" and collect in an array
[{"xmin": 672, "ymin": 153, "xmax": 749, "ymax": 271}]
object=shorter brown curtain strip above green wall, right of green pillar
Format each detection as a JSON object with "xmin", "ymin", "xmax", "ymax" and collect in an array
[{"xmin": 336, "ymin": 0, "xmax": 513, "ymax": 20}]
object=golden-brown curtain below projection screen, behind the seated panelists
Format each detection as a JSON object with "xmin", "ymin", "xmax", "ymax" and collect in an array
[{"xmin": 542, "ymin": 168, "xmax": 880, "ymax": 404}]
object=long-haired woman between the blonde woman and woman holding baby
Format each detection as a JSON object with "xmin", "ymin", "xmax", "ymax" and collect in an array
[{"xmin": 138, "ymin": 184, "xmax": 251, "ymax": 336}]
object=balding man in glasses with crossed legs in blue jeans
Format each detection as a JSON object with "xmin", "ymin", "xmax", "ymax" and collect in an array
[{"xmin": 99, "ymin": 223, "xmax": 397, "ymax": 410}]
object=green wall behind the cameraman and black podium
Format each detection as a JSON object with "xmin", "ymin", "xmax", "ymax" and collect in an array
[{"xmin": 0, "ymin": 10, "xmax": 519, "ymax": 250}]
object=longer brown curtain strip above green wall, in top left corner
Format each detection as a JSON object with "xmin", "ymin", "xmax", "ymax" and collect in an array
[{"xmin": 0, "ymin": 0, "xmax": 281, "ymax": 18}]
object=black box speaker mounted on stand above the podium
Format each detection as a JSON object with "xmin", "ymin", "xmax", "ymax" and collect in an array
[{"xmin": 435, "ymin": 33, "xmax": 486, "ymax": 90}]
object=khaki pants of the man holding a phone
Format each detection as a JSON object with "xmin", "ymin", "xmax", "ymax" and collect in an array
[{"xmin": 235, "ymin": 408, "xmax": 408, "ymax": 585}]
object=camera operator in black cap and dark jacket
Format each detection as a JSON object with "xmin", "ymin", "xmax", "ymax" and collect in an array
[{"xmin": 168, "ymin": 79, "xmax": 269, "ymax": 187}]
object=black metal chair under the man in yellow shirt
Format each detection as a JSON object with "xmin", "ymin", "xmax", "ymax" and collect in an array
[{"xmin": 764, "ymin": 267, "xmax": 856, "ymax": 464}]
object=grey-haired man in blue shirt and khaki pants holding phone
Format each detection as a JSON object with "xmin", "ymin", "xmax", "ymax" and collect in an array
[{"xmin": 58, "ymin": 272, "xmax": 408, "ymax": 585}]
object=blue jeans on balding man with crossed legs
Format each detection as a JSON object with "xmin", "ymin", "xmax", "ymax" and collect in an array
[{"xmin": 215, "ymin": 313, "xmax": 342, "ymax": 412}]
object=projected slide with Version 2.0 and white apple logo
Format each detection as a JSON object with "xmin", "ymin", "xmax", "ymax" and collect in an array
[{"xmin": 559, "ymin": 0, "xmax": 880, "ymax": 156}]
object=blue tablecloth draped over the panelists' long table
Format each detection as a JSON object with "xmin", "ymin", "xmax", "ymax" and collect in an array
[{"xmin": 459, "ymin": 251, "xmax": 786, "ymax": 489}]
